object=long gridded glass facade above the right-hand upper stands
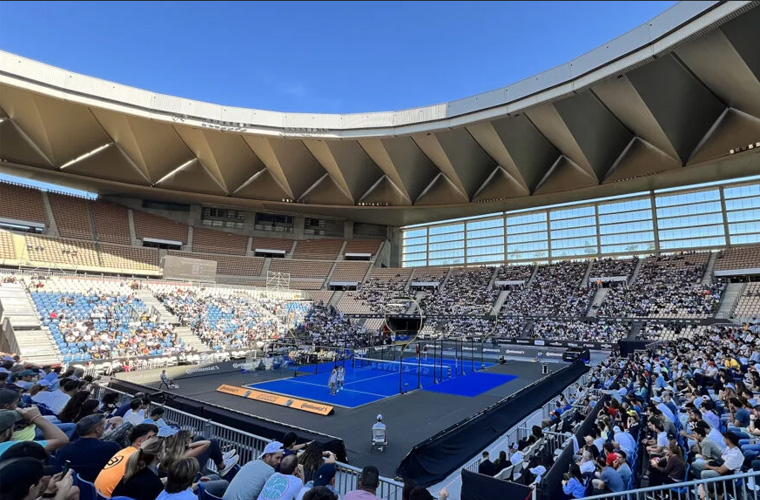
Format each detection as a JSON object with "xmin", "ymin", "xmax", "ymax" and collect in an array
[{"xmin": 402, "ymin": 179, "xmax": 760, "ymax": 267}]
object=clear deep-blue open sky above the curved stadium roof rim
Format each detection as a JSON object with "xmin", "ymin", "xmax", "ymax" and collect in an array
[{"xmin": 0, "ymin": 2, "xmax": 675, "ymax": 113}]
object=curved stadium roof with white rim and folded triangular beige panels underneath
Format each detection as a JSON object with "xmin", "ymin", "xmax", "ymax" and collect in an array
[{"xmin": 0, "ymin": 1, "xmax": 760, "ymax": 225}]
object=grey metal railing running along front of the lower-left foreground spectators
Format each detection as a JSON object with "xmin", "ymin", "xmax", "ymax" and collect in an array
[{"xmin": 93, "ymin": 386, "xmax": 404, "ymax": 500}]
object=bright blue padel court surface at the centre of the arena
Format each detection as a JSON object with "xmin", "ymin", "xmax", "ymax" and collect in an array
[{"xmin": 248, "ymin": 358, "xmax": 517, "ymax": 408}]
